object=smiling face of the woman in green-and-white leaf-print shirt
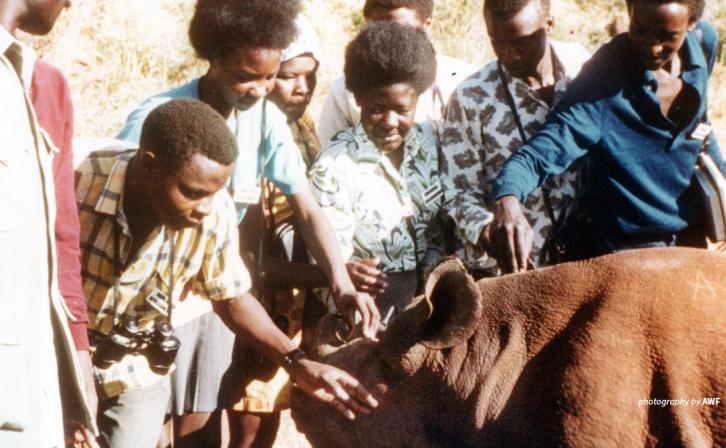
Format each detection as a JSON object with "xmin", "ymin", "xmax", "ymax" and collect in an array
[{"xmin": 356, "ymin": 83, "xmax": 418, "ymax": 154}]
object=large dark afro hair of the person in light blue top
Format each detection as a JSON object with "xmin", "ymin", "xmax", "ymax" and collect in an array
[{"xmin": 189, "ymin": 0, "xmax": 302, "ymax": 61}]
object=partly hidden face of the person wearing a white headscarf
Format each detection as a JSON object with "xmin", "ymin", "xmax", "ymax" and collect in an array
[{"xmin": 270, "ymin": 54, "xmax": 318, "ymax": 121}]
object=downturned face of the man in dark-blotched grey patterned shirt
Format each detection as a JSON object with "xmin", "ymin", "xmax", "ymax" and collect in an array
[{"xmin": 484, "ymin": 0, "xmax": 554, "ymax": 78}]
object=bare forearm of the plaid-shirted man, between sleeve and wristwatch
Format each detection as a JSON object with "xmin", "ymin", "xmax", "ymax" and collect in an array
[{"xmin": 212, "ymin": 293, "xmax": 297, "ymax": 365}]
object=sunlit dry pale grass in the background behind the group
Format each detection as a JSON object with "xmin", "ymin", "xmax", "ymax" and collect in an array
[{"xmin": 22, "ymin": 0, "xmax": 726, "ymax": 137}]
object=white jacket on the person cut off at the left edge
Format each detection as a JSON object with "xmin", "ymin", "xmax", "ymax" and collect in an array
[{"xmin": 0, "ymin": 26, "xmax": 66, "ymax": 447}]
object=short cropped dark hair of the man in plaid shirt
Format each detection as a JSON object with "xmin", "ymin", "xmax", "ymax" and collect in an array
[{"xmin": 139, "ymin": 98, "xmax": 237, "ymax": 173}]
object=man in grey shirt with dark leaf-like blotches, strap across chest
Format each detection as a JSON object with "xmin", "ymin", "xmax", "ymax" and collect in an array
[{"xmin": 441, "ymin": 0, "xmax": 589, "ymax": 276}]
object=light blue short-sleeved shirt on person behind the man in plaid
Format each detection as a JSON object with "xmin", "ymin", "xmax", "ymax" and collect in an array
[{"xmin": 117, "ymin": 79, "xmax": 308, "ymax": 221}]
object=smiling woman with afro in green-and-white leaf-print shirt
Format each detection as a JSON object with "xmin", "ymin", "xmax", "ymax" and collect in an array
[{"xmin": 310, "ymin": 21, "xmax": 443, "ymax": 322}]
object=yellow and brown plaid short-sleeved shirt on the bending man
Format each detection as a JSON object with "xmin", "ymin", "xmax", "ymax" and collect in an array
[{"xmin": 76, "ymin": 148, "xmax": 250, "ymax": 396}]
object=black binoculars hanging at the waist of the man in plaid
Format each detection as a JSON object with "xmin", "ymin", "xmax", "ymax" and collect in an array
[{"xmin": 93, "ymin": 316, "xmax": 181, "ymax": 375}]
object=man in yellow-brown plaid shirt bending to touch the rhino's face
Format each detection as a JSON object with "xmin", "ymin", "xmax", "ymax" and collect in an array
[{"xmin": 76, "ymin": 99, "xmax": 375, "ymax": 447}]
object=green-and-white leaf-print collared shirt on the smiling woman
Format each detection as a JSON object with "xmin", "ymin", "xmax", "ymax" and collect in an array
[{"xmin": 310, "ymin": 124, "xmax": 443, "ymax": 272}]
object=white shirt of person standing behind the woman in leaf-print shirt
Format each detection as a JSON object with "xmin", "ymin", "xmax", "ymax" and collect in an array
[{"xmin": 318, "ymin": 55, "xmax": 476, "ymax": 146}]
